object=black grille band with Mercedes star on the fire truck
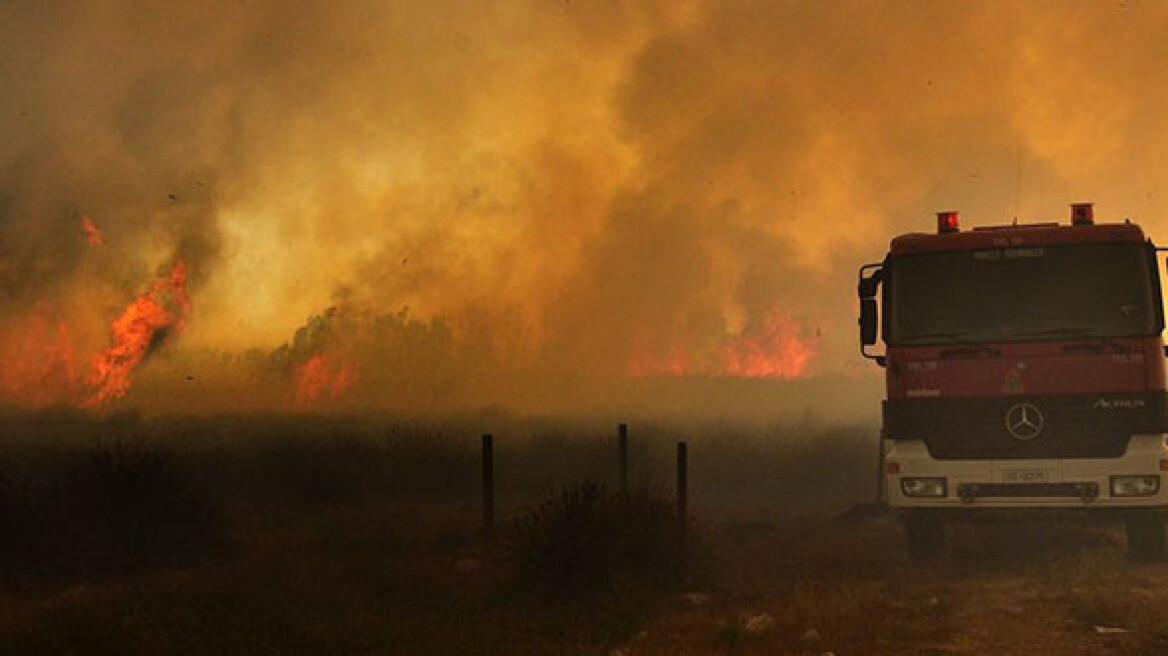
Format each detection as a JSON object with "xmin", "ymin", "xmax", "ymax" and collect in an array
[{"xmin": 884, "ymin": 391, "xmax": 1168, "ymax": 460}]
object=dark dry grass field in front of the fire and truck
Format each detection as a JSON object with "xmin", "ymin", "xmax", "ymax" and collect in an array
[{"xmin": 0, "ymin": 413, "xmax": 1168, "ymax": 656}]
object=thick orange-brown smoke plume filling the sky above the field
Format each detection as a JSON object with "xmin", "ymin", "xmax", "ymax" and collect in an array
[{"xmin": 0, "ymin": 0, "xmax": 1168, "ymax": 412}]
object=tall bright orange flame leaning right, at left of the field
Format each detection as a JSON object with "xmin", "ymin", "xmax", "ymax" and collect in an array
[{"xmin": 81, "ymin": 260, "xmax": 190, "ymax": 407}]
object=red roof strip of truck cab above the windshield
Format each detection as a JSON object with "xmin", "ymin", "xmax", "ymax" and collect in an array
[{"xmin": 889, "ymin": 223, "xmax": 1145, "ymax": 256}]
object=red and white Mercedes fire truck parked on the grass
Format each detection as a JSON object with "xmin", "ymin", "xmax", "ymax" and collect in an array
[{"xmin": 858, "ymin": 203, "xmax": 1168, "ymax": 559}]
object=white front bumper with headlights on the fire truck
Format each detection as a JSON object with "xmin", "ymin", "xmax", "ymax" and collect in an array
[{"xmin": 884, "ymin": 434, "xmax": 1168, "ymax": 510}]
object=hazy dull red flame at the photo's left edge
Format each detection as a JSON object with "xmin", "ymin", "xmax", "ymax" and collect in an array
[{"xmin": 0, "ymin": 307, "xmax": 81, "ymax": 407}]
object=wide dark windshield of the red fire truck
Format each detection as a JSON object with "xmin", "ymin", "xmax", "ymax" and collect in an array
[{"xmin": 884, "ymin": 244, "xmax": 1161, "ymax": 346}]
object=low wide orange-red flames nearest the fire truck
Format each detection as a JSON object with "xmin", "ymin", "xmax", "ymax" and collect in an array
[{"xmin": 630, "ymin": 310, "xmax": 816, "ymax": 379}]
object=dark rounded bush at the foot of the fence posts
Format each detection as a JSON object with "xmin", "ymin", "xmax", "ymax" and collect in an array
[{"xmin": 509, "ymin": 482, "xmax": 688, "ymax": 599}]
